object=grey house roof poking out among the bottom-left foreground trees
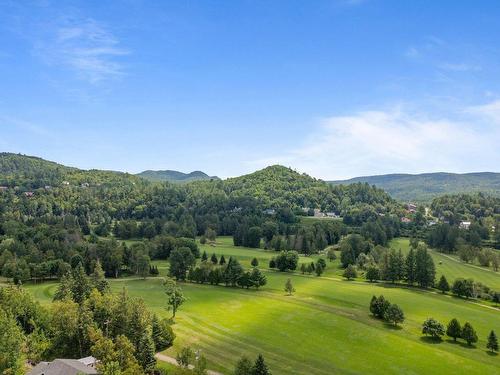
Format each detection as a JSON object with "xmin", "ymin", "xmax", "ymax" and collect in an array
[{"xmin": 28, "ymin": 357, "xmax": 99, "ymax": 375}]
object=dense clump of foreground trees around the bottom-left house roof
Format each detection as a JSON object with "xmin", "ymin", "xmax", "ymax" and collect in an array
[{"xmin": 0, "ymin": 263, "xmax": 175, "ymax": 375}]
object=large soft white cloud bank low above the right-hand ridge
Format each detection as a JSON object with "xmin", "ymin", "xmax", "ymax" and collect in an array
[{"xmin": 254, "ymin": 102, "xmax": 500, "ymax": 179}]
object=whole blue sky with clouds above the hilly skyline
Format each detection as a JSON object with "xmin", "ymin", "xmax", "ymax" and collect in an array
[{"xmin": 0, "ymin": 0, "xmax": 500, "ymax": 179}]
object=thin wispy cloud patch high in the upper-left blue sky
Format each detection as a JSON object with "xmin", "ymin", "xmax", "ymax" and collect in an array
[{"xmin": 35, "ymin": 18, "xmax": 130, "ymax": 84}]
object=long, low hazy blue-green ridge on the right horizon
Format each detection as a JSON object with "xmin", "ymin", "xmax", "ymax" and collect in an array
[{"xmin": 331, "ymin": 172, "xmax": 500, "ymax": 202}]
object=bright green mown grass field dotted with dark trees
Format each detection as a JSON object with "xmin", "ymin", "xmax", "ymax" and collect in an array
[{"xmin": 28, "ymin": 238, "xmax": 500, "ymax": 375}]
